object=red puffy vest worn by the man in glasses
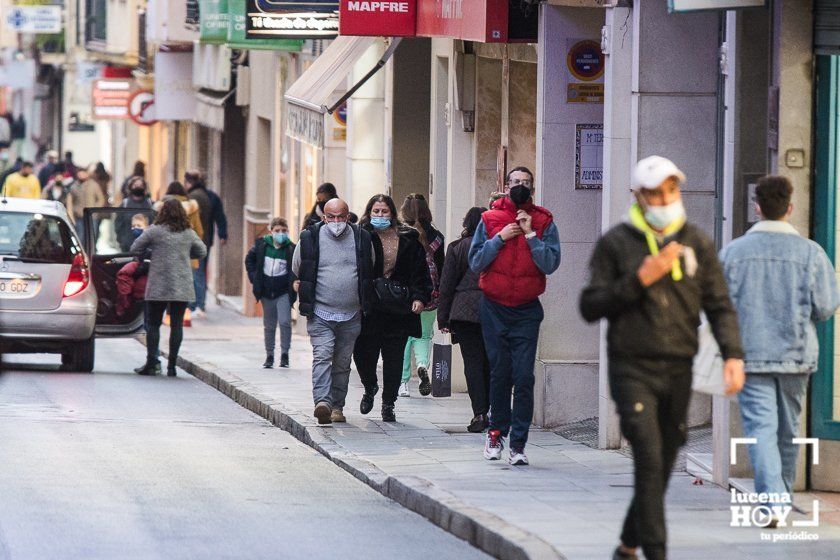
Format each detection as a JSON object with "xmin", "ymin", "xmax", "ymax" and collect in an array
[{"xmin": 478, "ymin": 197, "xmax": 552, "ymax": 307}]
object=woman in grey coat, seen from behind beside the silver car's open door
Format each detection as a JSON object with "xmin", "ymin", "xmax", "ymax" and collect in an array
[{"xmin": 131, "ymin": 197, "xmax": 207, "ymax": 377}]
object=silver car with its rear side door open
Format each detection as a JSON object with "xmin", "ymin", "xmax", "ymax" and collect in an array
[{"xmin": 0, "ymin": 198, "xmax": 151, "ymax": 372}]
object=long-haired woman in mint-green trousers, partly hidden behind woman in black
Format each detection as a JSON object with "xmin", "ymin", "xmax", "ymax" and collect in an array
[{"xmin": 399, "ymin": 193, "xmax": 444, "ymax": 397}]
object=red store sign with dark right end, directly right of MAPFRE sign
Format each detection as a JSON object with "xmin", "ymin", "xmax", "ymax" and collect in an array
[{"xmin": 417, "ymin": 0, "xmax": 538, "ymax": 43}]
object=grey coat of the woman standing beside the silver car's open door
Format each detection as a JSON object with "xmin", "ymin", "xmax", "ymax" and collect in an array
[{"xmin": 131, "ymin": 225, "xmax": 207, "ymax": 301}]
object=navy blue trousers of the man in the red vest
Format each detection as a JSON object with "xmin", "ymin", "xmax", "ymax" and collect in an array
[{"xmin": 480, "ymin": 297, "xmax": 544, "ymax": 449}]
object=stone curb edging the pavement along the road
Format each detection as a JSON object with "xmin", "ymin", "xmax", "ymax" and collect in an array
[{"xmin": 166, "ymin": 351, "xmax": 566, "ymax": 560}]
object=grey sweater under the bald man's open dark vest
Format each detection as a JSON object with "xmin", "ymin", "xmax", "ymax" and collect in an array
[{"xmin": 292, "ymin": 227, "xmax": 361, "ymax": 314}]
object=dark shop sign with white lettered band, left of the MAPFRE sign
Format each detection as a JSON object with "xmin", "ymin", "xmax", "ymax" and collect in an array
[{"xmin": 245, "ymin": 0, "xmax": 339, "ymax": 39}]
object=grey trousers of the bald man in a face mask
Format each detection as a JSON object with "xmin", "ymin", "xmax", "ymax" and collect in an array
[{"xmin": 306, "ymin": 312, "xmax": 362, "ymax": 409}]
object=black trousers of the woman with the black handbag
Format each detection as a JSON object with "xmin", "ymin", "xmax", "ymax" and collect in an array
[{"xmin": 353, "ymin": 322, "xmax": 408, "ymax": 404}]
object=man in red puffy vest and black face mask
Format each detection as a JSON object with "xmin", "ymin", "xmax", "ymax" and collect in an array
[{"xmin": 469, "ymin": 167, "xmax": 560, "ymax": 465}]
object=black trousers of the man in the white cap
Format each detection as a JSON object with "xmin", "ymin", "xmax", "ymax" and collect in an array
[{"xmin": 609, "ymin": 359, "xmax": 691, "ymax": 560}]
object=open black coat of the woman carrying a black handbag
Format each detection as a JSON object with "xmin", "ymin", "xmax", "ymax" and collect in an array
[{"xmin": 362, "ymin": 225, "xmax": 432, "ymax": 338}]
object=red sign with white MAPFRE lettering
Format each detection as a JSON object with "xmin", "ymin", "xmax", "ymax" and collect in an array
[{"xmin": 338, "ymin": 0, "xmax": 418, "ymax": 37}]
